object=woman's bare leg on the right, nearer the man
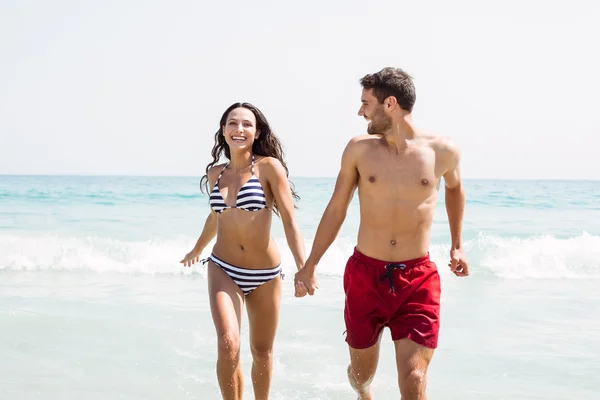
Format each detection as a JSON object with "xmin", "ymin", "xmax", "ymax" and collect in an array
[{"xmin": 246, "ymin": 275, "xmax": 281, "ymax": 400}]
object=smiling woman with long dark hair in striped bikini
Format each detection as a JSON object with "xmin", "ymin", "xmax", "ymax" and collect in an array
[{"xmin": 181, "ymin": 103, "xmax": 305, "ymax": 400}]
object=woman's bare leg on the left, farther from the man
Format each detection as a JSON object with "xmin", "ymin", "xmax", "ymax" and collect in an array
[{"xmin": 208, "ymin": 261, "xmax": 244, "ymax": 400}]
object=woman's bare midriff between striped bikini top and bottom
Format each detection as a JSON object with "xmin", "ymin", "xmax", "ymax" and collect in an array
[{"xmin": 212, "ymin": 208, "xmax": 281, "ymax": 269}]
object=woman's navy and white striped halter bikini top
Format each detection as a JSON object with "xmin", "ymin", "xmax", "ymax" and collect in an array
[{"xmin": 209, "ymin": 154, "xmax": 267, "ymax": 214}]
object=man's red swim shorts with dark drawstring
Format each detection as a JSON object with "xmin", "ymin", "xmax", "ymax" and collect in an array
[{"xmin": 344, "ymin": 249, "xmax": 441, "ymax": 349}]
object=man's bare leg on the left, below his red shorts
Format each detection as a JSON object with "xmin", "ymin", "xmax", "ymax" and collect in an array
[{"xmin": 348, "ymin": 334, "xmax": 381, "ymax": 400}]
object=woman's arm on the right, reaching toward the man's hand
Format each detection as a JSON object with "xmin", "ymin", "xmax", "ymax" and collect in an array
[{"xmin": 265, "ymin": 158, "xmax": 306, "ymax": 270}]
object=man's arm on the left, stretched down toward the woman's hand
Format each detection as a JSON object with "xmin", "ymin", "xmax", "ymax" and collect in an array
[{"xmin": 303, "ymin": 137, "xmax": 360, "ymax": 275}]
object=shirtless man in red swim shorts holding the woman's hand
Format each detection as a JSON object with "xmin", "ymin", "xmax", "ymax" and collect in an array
[{"xmin": 295, "ymin": 68, "xmax": 469, "ymax": 400}]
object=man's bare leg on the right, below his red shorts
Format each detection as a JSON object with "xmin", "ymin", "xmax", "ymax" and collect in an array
[{"xmin": 394, "ymin": 339, "xmax": 434, "ymax": 400}]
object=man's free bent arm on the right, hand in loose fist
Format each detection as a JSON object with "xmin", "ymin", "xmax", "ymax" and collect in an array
[{"xmin": 440, "ymin": 139, "xmax": 469, "ymax": 276}]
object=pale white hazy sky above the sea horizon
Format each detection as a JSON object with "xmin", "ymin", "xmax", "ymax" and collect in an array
[{"xmin": 0, "ymin": 0, "xmax": 600, "ymax": 179}]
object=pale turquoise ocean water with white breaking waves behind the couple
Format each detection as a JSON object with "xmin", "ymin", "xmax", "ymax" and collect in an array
[{"xmin": 0, "ymin": 176, "xmax": 600, "ymax": 400}]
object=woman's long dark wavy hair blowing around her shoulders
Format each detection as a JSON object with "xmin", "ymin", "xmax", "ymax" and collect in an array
[{"xmin": 200, "ymin": 103, "xmax": 300, "ymax": 215}]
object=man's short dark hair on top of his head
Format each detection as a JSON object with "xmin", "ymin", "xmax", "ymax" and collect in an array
[{"xmin": 360, "ymin": 67, "xmax": 417, "ymax": 112}]
